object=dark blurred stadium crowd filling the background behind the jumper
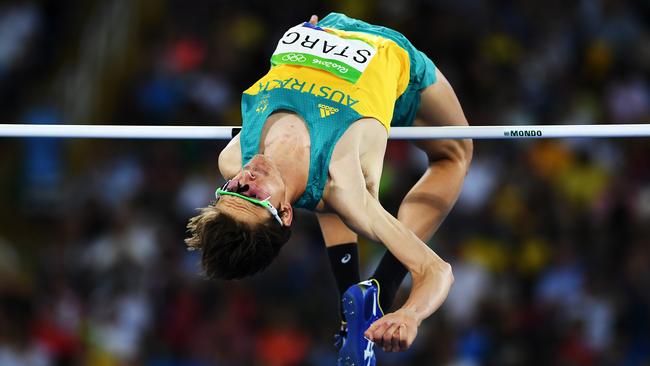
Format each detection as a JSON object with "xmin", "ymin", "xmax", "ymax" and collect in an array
[{"xmin": 0, "ymin": 0, "xmax": 650, "ymax": 366}]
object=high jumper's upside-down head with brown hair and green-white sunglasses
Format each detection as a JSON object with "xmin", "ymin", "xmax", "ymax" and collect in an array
[{"xmin": 186, "ymin": 155, "xmax": 293, "ymax": 279}]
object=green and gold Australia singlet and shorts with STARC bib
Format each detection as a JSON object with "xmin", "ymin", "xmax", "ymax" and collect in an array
[{"xmin": 240, "ymin": 13, "xmax": 435, "ymax": 209}]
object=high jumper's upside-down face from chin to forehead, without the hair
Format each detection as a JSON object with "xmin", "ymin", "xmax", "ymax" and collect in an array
[{"xmin": 217, "ymin": 155, "xmax": 291, "ymax": 226}]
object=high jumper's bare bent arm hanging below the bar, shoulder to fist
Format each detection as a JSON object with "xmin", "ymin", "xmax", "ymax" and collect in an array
[{"xmin": 323, "ymin": 120, "xmax": 453, "ymax": 351}]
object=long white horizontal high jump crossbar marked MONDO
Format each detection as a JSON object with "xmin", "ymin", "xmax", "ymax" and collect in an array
[{"xmin": 0, "ymin": 124, "xmax": 650, "ymax": 140}]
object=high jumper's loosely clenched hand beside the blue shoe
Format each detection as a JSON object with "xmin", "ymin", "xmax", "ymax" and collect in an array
[{"xmin": 364, "ymin": 309, "xmax": 418, "ymax": 352}]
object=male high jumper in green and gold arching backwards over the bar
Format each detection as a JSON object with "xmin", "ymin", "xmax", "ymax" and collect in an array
[{"xmin": 186, "ymin": 13, "xmax": 472, "ymax": 365}]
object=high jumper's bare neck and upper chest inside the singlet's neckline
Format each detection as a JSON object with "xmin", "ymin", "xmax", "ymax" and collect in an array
[{"xmin": 260, "ymin": 112, "xmax": 310, "ymax": 203}]
